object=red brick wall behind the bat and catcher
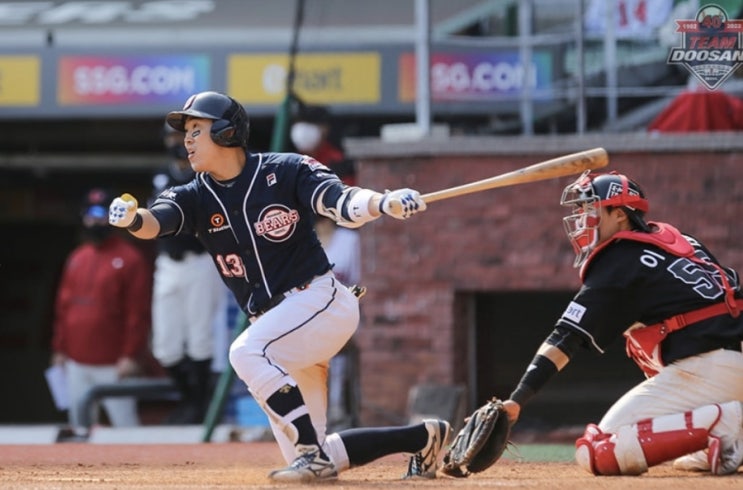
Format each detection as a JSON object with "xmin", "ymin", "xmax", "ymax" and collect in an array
[{"xmin": 347, "ymin": 134, "xmax": 743, "ymax": 424}]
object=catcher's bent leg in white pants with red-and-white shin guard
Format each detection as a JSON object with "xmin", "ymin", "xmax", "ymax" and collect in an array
[{"xmin": 576, "ymin": 349, "xmax": 743, "ymax": 475}]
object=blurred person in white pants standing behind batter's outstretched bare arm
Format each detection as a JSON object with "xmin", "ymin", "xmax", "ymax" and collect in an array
[{"xmin": 147, "ymin": 124, "xmax": 228, "ymax": 425}]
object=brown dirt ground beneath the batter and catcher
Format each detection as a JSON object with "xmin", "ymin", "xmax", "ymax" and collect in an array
[{"xmin": 0, "ymin": 442, "xmax": 743, "ymax": 490}]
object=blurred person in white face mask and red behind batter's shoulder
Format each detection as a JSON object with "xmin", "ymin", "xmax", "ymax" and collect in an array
[{"xmin": 289, "ymin": 105, "xmax": 356, "ymax": 186}]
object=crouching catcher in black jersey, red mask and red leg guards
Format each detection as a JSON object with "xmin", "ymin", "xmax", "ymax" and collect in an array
[{"xmin": 496, "ymin": 172, "xmax": 743, "ymax": 475}]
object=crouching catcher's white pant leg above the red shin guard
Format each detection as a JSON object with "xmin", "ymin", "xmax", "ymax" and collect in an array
[{"xmin": 598, "ymin": 349, "xmax": 743, "ymax": 433}]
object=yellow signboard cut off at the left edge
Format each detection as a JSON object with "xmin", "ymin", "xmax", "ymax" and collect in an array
[{"xmin": 0, "ymin": 56, "xmax": 41, "ymax": 106}]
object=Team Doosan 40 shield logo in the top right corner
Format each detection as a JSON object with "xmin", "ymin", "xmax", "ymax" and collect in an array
[{"xmin": 668, "ymin": 4, "xmax": 743, "ymax": 90}]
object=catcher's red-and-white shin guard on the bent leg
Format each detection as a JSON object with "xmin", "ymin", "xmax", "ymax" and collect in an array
[{"xmin": 575, "ymin": 405, "xmax": 720, "ymax": 475}]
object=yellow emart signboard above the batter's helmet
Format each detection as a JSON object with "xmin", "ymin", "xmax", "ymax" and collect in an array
[{"xmin": 227, "ymin": 52, "xmax": 382, "ymax": 105}]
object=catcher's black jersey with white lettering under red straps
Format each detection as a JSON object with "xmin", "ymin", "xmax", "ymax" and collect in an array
[{"xmin": 557, "ymin": 226, "xmax": 743, "ymax": 364}]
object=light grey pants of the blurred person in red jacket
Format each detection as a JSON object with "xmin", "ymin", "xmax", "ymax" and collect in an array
[{"xmin": 65, "ymin": 359, "xmax": 139, "ymax": 429}]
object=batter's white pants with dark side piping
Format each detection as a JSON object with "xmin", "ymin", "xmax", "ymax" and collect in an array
[{"xmin": 230, "ymin": 272, "xmax": 359, "ymax": 463}]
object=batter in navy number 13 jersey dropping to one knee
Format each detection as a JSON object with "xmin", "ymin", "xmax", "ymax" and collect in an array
[{"xmin": 109, "ymin": 92, "xmax": 451, "ymax": 483}]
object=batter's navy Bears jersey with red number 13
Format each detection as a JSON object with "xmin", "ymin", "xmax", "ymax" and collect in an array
[{"xmin": 151, "ymin": 153, "xmax": 343, "ymax": 315}]
